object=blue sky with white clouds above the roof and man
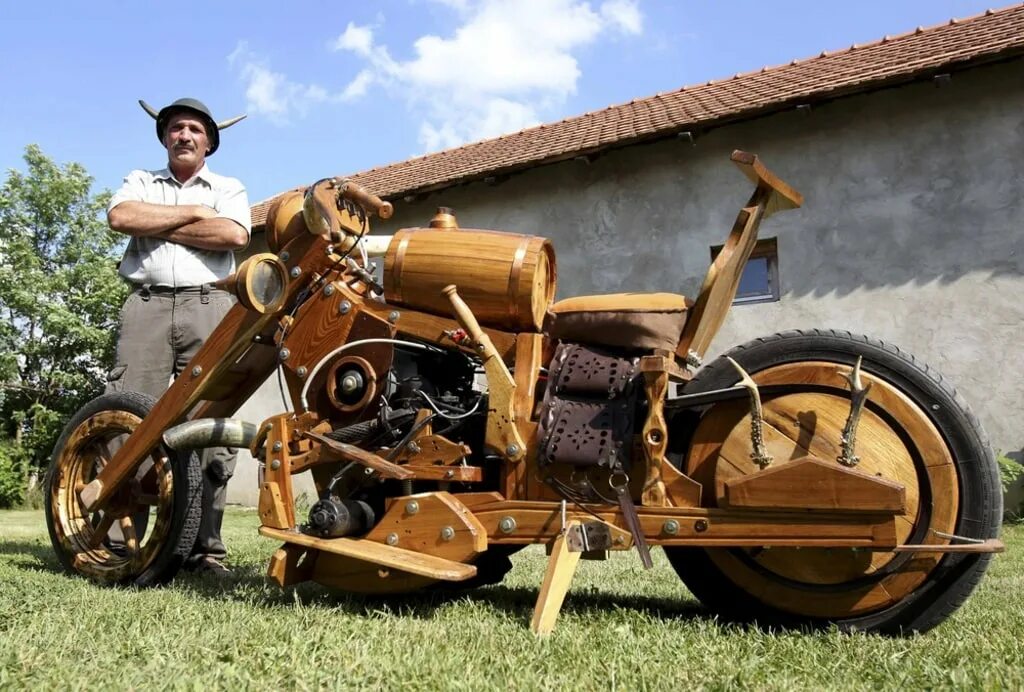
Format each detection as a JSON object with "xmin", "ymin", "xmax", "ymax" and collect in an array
[{"xmin": 0, "ymin": 0, "xmax": 1005, "ymax": 203}]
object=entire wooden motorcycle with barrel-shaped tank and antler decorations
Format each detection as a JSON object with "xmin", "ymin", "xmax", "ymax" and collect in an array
[{"xmin": 46, "ymin": 152, "xmax": 1002, "ymax": 634}]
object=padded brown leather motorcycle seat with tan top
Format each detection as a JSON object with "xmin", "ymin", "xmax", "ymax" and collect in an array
[{"xmin": 544, "ymin": 293, "xmax": 693, "ymax": 351}]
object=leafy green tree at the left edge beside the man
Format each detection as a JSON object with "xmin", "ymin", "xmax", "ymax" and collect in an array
[{"xmin": 0, "ymin": 144, "xmax": 128, "ymax": 467}]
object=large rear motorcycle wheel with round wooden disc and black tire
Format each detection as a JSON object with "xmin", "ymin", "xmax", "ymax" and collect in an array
[{"xmin": 666, "ymin": 331, "xmax": 1002, "ymax": 634}]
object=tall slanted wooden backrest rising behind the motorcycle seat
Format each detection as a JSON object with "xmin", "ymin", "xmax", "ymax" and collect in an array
[{"xmin": 676, "ymin": 150, "xmax": 804, "ymax": 359}]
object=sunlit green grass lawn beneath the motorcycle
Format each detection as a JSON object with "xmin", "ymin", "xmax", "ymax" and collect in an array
[{"xmin": 0, "ymin": 511, "xmax": 1024, "ymax": 690}]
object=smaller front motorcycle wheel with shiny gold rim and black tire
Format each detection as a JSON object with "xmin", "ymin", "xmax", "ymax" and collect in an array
[{"xmin": 44, "ymin": 392, "xmax": 203, "ymax": 587}]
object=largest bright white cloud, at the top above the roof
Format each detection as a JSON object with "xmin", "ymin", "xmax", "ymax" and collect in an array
[{"xmin": 332, "ymin": 0, "xmax": 642, "ymax": 152}]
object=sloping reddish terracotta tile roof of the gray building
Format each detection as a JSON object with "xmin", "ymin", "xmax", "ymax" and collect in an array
[{"xmin": 252, "ymin": 4, "xmax": 1024, "ymax": 226}]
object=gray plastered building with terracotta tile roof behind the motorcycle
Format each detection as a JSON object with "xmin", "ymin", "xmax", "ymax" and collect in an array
[{"xmin": 232, "ymin": 5, "xmax": 1024, "ymax": 503}]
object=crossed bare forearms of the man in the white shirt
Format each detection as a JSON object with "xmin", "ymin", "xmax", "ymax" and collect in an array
[{"xmin": 106, "ymin": 202, "xmax": 249, "ymax": 250}]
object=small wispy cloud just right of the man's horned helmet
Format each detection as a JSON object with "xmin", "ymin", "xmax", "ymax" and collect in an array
[{"xmin": 227, "ymin": 41, "xmax": 331, "ymax": 125}]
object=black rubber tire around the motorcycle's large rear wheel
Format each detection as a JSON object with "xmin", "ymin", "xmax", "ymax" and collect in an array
[{"xmin": 666, "ymin": 331, "xmax": 1002, "ymax": 635}]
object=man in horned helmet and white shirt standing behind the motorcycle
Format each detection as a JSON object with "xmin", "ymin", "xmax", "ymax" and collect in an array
[{"xmin": 106, "ymin": 98, "xmax": 251, "ymax": 575}]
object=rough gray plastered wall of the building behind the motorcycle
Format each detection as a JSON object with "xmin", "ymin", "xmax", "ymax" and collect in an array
[{"xmin": 228, "ymin": 60, "xmax": 1024, "ymax": 503}]
